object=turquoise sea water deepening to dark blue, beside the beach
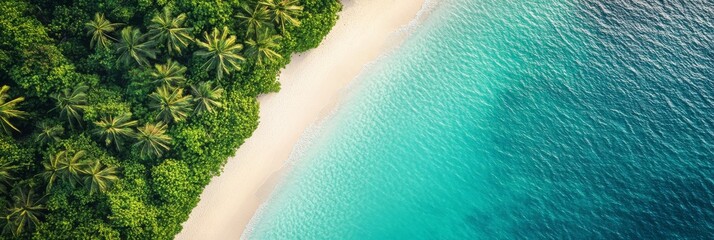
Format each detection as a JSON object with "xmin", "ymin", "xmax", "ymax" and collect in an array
[{"xmin": 246, "ymin": 0, "xmax": 714, "ymax": 239}]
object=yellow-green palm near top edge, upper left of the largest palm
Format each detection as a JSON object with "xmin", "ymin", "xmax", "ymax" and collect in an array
[{"xmin": 148, "ymin": 8, "xmax": 193, "ymax": 55}]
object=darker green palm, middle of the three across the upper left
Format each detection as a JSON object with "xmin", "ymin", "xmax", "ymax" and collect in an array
[{"xmin": 116, "ymin": 26, "xmax": 156, "ymax": 66}]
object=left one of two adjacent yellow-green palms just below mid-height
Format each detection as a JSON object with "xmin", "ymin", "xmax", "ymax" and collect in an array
[{"xmin": 93, "ymin": 114, "xmax": 138, "ymax": 150}]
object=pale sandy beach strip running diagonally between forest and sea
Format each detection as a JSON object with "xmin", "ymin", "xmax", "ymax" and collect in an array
[{"xmin": 176, "ymin": 0, "xmax": 424, "ymax": 240}]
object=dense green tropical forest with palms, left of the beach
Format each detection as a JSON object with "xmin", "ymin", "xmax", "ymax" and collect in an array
[{"xmin": 0, "ymin": 0, "xmax": 341, "ymax": 239}]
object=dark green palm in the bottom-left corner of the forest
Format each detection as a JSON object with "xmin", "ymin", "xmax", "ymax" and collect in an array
[{"xmin": 3, "ymin": 187, "xmax": 47, "ymax": 236}]
